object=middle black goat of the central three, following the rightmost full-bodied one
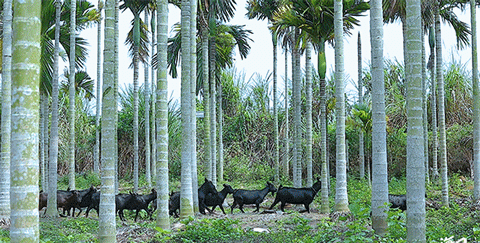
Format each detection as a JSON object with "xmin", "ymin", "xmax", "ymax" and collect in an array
[{"xmin": 230, "ymin": 182, "xmax": 277, "ymax": 213}]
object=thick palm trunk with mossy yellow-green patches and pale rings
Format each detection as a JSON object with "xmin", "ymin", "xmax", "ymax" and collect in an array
[{"xmin": 10, "ymin": 0, "xmax": 41, "ymax": 242}]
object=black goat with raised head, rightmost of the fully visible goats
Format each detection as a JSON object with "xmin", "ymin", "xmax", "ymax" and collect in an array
[{"xmin": 270, "ymin": 180, "xmax": 322, "ymax": 213}]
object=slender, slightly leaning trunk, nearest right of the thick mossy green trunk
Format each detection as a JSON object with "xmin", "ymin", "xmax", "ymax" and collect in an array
[{"xmin": 47, "ymin": 1, "xmax": 62, "ymax": 217}]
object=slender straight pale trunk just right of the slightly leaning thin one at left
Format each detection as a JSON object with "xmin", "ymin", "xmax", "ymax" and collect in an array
[{"xmin": 68, "ymin": 0, "xmax": 77, "ymax": 190}]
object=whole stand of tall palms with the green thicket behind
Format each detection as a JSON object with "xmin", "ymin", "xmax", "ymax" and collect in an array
[{"xmin": 0, "ymin": 0, "xmax": 480, "ymax": 242}]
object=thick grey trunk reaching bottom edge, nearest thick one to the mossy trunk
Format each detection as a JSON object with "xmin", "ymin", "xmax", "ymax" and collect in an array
[{"xmin": 98, "ymin": 0, "xmax": 117, "ymax": 239}]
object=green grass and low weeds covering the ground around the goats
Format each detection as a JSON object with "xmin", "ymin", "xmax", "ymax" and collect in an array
[{"xmin": 0, "ymin": 174, "xmax": 480, "ymax": 242}]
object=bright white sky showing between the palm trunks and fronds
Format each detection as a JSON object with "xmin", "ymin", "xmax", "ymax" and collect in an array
[{"xmin": 79, "ymin": 0, "xmax": 480, "ymax": 106}]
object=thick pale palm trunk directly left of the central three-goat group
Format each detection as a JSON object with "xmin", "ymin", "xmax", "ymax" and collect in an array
[{"xmin": 180, "ymin": 0, "xmax": 195, "ymax": 218}]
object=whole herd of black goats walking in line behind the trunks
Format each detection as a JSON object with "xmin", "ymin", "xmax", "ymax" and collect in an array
[{"xmin": 38, "ymin": 179, "xmax": 406, "ymax": 221}]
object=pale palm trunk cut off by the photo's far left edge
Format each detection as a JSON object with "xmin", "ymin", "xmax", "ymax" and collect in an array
[{"xmin": 0, "ymin": 0, "xmax": 12, "ymax": 219}]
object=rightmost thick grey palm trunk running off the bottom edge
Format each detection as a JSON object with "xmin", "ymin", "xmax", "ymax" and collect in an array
[{"xmin": 405, "ymin": 0, "xmax": 426, "ymax": 242}]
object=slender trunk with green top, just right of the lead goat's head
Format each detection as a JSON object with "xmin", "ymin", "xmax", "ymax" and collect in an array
[{"xmin": 317, "ymin": 40, "xmax": 330, "ymax": 213}]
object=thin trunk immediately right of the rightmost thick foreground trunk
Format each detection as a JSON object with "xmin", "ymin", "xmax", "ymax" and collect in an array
[{"xmin": 422, "ymin": 25, "xmax": 430, "ymax": 183}]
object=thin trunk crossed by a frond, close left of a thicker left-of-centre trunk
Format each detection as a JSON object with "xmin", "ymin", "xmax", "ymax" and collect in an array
[{"xmin": 150, "ymin": 10, "xmax": 158, "ymax": 182}]
